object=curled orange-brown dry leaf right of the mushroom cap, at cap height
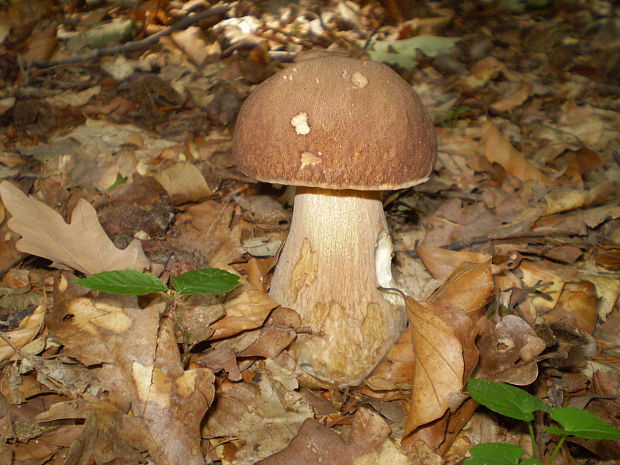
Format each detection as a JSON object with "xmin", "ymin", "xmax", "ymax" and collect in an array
[{"xmin": 481, "ymin": 121, "xmax": 545, "ymax": 181}]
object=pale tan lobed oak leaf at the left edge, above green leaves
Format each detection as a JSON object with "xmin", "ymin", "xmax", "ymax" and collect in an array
[{"xmin": 0, "ymin": 181, "xmax": 150, "ymax": 274}]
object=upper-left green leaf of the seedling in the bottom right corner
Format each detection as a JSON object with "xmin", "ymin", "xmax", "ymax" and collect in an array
[{"xmin": 467, "ymin": 379, "xmax": 551, "ymax": 421}]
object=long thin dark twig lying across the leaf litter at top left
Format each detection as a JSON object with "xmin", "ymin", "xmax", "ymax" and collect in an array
[{"xmin": 28, "ymin": 5, "xmax": 231, "ymax": 68}]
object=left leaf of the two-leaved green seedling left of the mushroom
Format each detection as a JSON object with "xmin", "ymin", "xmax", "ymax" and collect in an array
[{"xmin": 75, "ymin": 270, "xmax": 168, "ymax": 295}]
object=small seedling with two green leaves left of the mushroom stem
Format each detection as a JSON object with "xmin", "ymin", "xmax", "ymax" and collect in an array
[{"xmin": 74, "ymin": 268, "xmax": 239, "ymax": 296}]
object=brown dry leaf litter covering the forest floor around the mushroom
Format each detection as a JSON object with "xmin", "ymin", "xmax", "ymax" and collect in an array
[{"xmin": 0, "ymin": 1, "xmax": 620, "ymax": 465}]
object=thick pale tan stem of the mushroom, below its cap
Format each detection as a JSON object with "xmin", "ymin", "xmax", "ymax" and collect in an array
[{"xmin": 270, "ymin": 187, "xmax": 406, "ymax": 386}]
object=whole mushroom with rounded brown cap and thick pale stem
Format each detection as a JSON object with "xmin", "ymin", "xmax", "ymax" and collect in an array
[{"xmin": 233, "ymin": 56, "xmax": 436, "ymax": 386}]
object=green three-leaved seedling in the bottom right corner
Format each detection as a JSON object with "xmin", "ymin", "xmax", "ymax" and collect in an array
[{"xmin": 463, "ymin": 379, "xmax": 620, "ymax": 465}]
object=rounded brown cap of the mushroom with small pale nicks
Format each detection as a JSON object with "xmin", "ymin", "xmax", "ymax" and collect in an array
[{"xmin": 233, "ymin": 56, "xmax": 437, "ymax": 190}]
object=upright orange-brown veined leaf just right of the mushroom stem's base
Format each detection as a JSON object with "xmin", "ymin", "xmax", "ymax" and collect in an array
[{"xmin": 405, "ymin": 298, "xmax": 464, "ymax": 434}]
